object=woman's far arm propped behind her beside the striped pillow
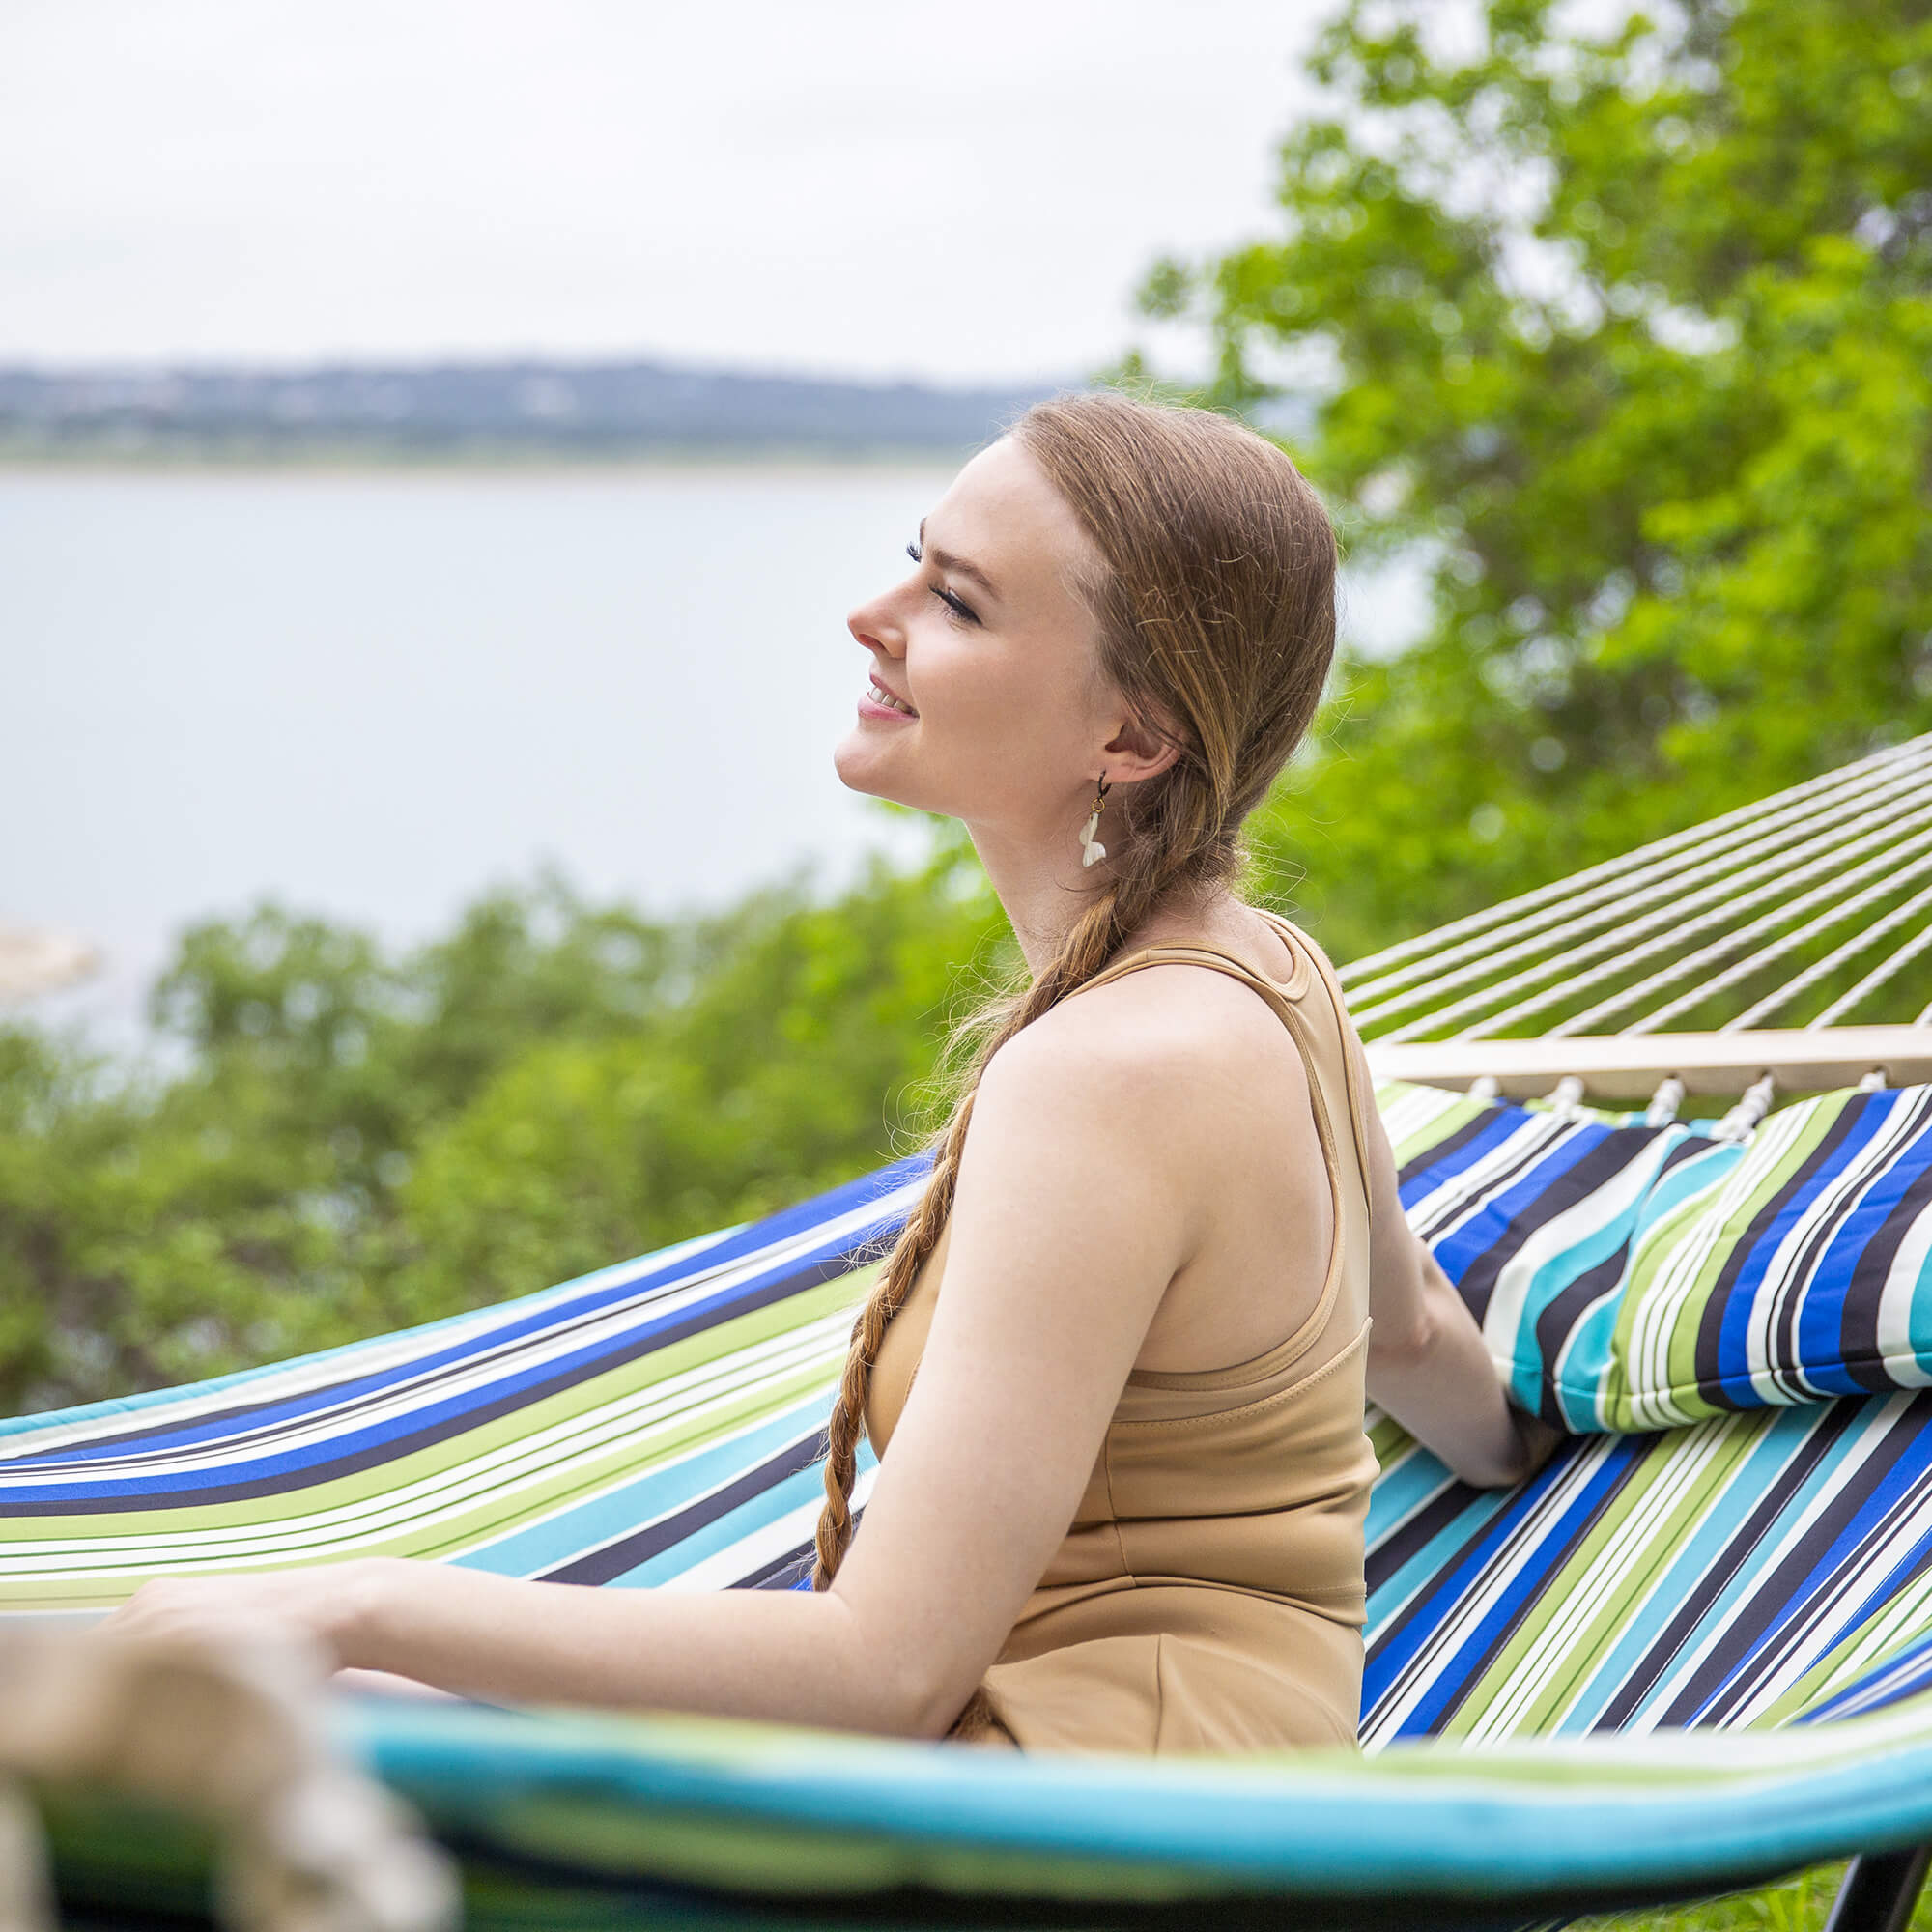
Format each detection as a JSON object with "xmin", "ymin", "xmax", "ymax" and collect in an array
[{"xmin": 1350, "ymin": 1041, "xmax": 1563, "ymax": 1488}]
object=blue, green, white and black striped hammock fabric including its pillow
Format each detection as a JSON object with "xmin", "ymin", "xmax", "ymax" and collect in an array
[{"xmin": 11, "ymin": 1086, "xmax": 1932, "ymax": 1924}]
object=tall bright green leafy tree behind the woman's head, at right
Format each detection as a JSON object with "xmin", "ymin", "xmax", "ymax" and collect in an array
[{"xmin": 1128, "ymin": 0, "xmax": 1932, "ymax": 954}]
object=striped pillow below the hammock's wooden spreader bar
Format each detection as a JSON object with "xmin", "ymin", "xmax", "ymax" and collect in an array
[{"xmin": 1376, "ymin": 1082, "xmax": 1932, "ymax": 1432}]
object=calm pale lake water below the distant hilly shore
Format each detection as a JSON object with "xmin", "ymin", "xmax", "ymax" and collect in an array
[{"xmin": 0, "ymin": 464, "xmax": 1420, "ymax": 1037}]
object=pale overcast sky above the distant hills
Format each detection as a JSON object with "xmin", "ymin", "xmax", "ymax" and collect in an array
[{"xmin": 0, "ymin": 0, "xmax": 1321, "ymax": 381}]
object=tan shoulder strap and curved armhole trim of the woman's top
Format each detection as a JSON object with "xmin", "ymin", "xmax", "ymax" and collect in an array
[{"xmin": 1066, "ymin": 908, "xmax": 1370, "ymax": 1389}]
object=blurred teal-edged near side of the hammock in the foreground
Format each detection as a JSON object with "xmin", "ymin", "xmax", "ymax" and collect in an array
[{"xmin": 334, "ymin": 1696, "xmax": 1932, "ymax": 1907}]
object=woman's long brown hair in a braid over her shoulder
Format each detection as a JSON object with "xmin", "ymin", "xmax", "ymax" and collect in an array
[{"xmin": 811, "ymin": 392, "xmax": 1335, "ymax": 1631}]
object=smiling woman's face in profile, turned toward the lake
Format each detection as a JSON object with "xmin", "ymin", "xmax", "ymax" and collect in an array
[{"xmin": 833, "ymin": 437, "xmax": 1126, "ymax": 835}]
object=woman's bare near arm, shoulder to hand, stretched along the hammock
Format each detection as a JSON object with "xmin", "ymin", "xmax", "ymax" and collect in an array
[{"xmin": 110, "ymin": 1001, "xmax": 1209, "ymax": 1737}]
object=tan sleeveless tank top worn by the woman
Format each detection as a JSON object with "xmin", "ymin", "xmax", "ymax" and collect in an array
[{"xmin": 866, "ymin": 914, "xmax": 1376, "ymax": 1752}]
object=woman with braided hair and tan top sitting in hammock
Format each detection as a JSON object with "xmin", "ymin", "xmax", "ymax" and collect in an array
[{"xmin": 110, "ymin": 396, "xmax": 1549, "ymax": 1752}]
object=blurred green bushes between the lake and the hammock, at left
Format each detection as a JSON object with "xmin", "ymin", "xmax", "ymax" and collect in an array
[{"xmin": 0, "ymin": 846, "xmax": 1012, "ymax": 1412}]
